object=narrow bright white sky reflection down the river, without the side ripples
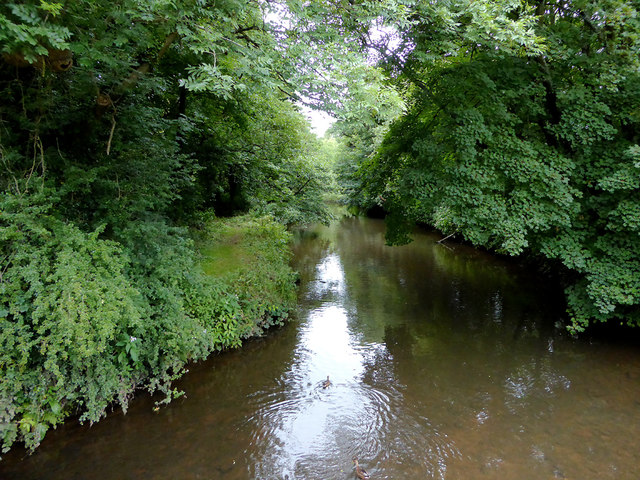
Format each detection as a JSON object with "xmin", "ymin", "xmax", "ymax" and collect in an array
[{"xmin": 250, "ymin": 254, "xmax": 371, "ymax": 478}]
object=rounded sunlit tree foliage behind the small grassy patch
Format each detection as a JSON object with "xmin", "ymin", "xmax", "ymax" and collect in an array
[{"xmin": 178, "ymin": 89, "xmax": 332, "ymax": 225}]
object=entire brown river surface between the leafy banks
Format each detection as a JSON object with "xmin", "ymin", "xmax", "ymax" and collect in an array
[{"xmin": 0, "ymin": 219, "xmax": 640, "ymax": 480}]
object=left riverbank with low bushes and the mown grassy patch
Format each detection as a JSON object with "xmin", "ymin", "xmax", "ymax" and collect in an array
[{"xmin": 0, "ymin": 216, "xmax": 295, "ymax": 453}]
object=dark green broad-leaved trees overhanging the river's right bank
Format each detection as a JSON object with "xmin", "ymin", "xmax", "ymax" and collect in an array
[{"xmin": 328, "ymin": 0, "xmax": 640, "ymax": 331}]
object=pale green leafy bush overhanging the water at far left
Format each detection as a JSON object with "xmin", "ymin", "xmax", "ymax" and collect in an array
[{"xmin": 0, "ymin": 190, "xmax": 143, "ymax": 451}]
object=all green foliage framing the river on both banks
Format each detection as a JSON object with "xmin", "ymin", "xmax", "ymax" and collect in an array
[{"xmin": 0, "ymin": 0, "xmax": 640, "ymax": 458}]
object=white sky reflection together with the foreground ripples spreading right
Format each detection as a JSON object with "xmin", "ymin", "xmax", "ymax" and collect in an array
[{"xmin": 249, "ymin": 248, "xmax": 457, "ymax": 479}]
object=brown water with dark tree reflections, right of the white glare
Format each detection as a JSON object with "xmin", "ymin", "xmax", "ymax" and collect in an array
[{"xmin": 288, "ymin": 219, "xmax": 640, "ymax": 479}]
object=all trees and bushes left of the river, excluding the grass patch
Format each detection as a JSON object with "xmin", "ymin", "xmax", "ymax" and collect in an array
[{"xmin": 0, "ymin": 0, "xmax": 328, "ymax": 451}]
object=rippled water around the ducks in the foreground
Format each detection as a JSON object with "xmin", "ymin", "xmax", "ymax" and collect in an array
[{"xmin": 243, "ymin": 362, "xmax": 460, "ymax": 479}]
